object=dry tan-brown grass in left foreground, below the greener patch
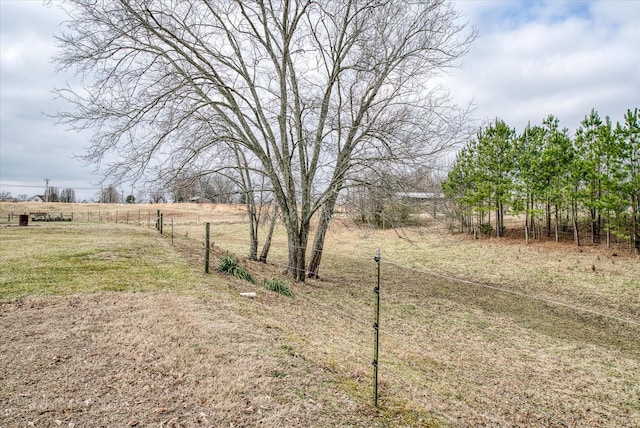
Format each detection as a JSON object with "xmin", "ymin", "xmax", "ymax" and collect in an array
[{"xmin": 0, "ymin": 293, "xmax": 364, "ymax": 428}]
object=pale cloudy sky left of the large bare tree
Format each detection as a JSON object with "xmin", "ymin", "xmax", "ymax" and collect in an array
[{"xmin": 0, "ymin": 0, "xmax": 98, "ymax": 198}]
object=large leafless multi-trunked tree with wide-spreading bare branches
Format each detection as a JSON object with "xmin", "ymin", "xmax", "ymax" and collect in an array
[{"xmin": 56, "ymin": 0, "xmax": 475, "ymax": 280}]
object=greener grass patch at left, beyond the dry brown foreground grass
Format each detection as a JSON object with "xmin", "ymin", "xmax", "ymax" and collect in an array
[{"xmin": 0, "ymin": 224, "xmax": 200, "ymax": 300}]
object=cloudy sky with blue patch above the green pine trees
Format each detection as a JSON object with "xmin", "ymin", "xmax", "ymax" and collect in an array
[{"xmin": 446, "ymin": 1, "xmax": 640, "ymax": 130}]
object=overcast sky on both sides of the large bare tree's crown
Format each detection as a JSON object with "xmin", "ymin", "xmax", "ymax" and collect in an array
[{"xmin": 0, "ymin": 0, "xmax": 640, "ymax": 199}]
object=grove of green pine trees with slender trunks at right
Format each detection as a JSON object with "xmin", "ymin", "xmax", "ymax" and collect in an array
[{"xmin": 443, "ymin": 108, "xmax": 640, "ymax": 251}]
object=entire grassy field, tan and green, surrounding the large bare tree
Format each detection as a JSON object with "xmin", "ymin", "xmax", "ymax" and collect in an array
[{"xmin": 0, "ymin": 204, "xmax": 640, "ymax": 427}]
